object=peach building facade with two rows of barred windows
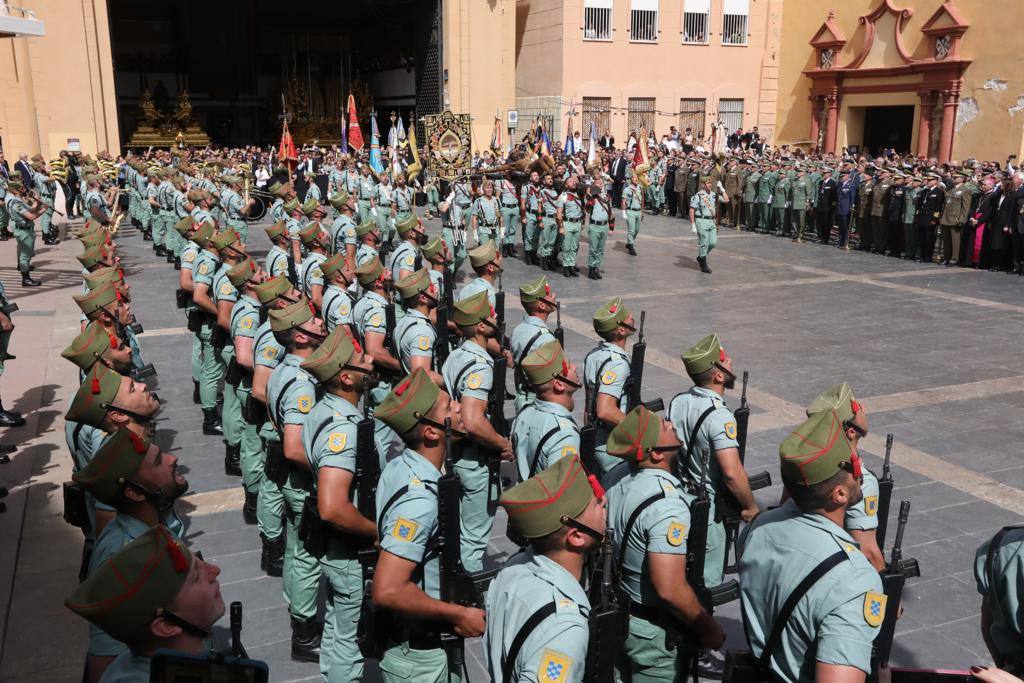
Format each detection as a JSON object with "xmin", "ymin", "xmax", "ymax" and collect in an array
[{"xmin": 516, "ymin": 0, "xmax": 782, "ymax": 146}]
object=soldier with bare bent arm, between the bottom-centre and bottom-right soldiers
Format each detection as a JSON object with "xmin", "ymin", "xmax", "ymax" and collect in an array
[{"xmin": 607, "ymin": 405, "xmax": 725, "ymax": 681}]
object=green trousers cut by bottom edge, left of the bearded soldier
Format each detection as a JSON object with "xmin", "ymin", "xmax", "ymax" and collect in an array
[{"xmin": 321, "ymin": 561, "xmax": 364, "ymax": 683}]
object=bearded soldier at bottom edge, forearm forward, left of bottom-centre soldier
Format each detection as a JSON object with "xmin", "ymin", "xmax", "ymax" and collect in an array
[{"xmin": 374, "ymin": 370, "xmax": 484, "ymax": 683}]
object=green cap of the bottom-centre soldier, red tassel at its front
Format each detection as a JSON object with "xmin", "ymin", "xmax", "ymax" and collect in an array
[{"xmin": 498, "ymin": 456, "xmax": 594, "ymax": 539}]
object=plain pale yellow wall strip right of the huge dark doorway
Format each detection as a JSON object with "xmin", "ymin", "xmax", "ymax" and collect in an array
[{"xmin": 441, "ymin": 0, "xmax": 516, "ymax": 150}]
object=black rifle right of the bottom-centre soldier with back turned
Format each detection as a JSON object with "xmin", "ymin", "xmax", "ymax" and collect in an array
[{"xmin": 583, "ymin": 526, "xmax": 628, "ymax": 683}]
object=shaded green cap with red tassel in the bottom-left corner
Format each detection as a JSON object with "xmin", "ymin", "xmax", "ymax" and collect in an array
[{"xmin": 65, "ymin": 526, "xmax": 193, "ymax": 641}]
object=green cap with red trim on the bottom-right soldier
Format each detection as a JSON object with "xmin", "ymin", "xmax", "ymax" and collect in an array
[{"xmin": 778, "ymin": 411, "xmax": 853, "ymax": 486}]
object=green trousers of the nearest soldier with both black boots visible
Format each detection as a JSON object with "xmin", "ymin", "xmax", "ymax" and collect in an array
[{"xmin": 281, "ymin": 467, "xmax": 321, "ymax": 620}]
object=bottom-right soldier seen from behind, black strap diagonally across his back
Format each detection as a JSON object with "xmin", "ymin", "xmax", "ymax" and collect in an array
[{"xmin": 737, "ymin": 411, "xmax": 886, "ymax": 683}]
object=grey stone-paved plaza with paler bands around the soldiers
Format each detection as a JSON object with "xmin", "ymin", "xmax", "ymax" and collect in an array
[{"xmin": 0, "ymin": 210, "xmax": 1024, "ymax": 681}]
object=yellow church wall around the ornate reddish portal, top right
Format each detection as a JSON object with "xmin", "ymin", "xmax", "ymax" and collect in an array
[{"xmin": 775, "ymin": 0, "xmax": 1024, "ymax": 162}]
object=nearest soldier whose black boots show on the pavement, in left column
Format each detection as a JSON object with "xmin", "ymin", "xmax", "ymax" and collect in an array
[{"xmin": 266, "ymin": 300, "xmax": 326, "ymax": 661}]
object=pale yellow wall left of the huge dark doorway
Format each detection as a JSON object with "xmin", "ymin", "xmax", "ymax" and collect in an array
[{"xmin": 0, "ymin": 0, "xmax": 120, "ymax": 161}]
